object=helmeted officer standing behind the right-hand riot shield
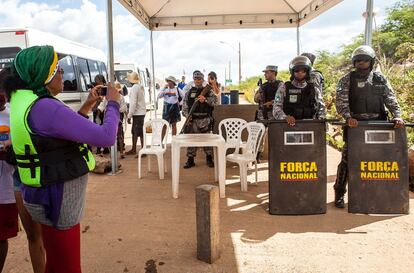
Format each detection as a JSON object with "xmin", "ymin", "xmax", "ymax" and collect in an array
[{"xmin": 334, "ymin": 45, "xmax": 404, "ymax": 208}]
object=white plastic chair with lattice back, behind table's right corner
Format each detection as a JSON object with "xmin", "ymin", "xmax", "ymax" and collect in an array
[{"xmin": 218, "ymin": 118, "xmax": 247, "ymax": 152}]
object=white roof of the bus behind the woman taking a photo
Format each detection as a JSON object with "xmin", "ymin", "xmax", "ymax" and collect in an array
[{"xmin": 0, "ymin": 28, "xmax": 107, "ymax": 63}]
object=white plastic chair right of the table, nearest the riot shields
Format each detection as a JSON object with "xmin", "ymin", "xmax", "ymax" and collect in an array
[{"xmin": 226, "ymin": 122, "xmax": 266, "ymax": 191}]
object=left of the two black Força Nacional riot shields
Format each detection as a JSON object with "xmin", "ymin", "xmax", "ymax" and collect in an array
[{"xmin": 268, "ymin": 120, "xmax": 326, "ymax": 215}]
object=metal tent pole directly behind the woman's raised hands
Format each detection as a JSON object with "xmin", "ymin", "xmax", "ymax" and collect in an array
[{"xmin": 106, "ymin": 0, "xmax": 118, "ymax": 174}]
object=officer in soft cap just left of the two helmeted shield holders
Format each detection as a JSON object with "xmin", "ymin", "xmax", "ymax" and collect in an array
[{"xmin": 254, "ymin": 65, "xmax": 282, "ymax": 120}]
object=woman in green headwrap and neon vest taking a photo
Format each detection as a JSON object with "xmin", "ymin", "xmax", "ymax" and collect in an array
[{"xmin": 1, "ymin": 46, "xmax": 119, "ymax": 273}]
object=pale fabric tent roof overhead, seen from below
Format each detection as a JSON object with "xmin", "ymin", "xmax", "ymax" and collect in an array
[{"xmin": 118, "ymin": 0, "xmax": 342, "ymax": 31}]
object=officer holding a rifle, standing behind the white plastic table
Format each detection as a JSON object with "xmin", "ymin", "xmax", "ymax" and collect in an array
[{"xmin": 182, "ymin": 70, "xmax": 217, "ymax": 169}]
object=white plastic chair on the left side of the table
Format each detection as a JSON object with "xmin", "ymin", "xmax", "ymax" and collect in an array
[{"xmin": 138, "ymin": 119, "xmax": 170, "ymax": 179}]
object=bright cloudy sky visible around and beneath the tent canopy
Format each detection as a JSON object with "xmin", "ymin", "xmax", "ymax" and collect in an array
[{"xmin": 0, "ymin": 0, "xmax": 398, "ymax": 83}]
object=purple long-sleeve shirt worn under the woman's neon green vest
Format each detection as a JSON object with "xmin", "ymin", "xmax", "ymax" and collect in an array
[{"xmin": 22, "ymin": 98, "xmax": 119, "ymax": 226}]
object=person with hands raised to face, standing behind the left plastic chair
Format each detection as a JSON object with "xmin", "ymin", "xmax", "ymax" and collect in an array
[{"xmin": 158, "ymin": 76, "xmax": 184, "ymax": 137}]
